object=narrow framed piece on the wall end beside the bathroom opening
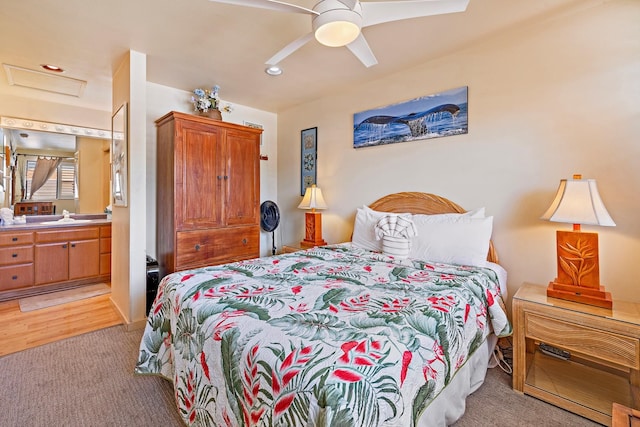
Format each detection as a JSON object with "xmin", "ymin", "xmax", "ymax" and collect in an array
[{"xmin": 111, "ymin": 103, "xmax": 129, "ymax": 207}]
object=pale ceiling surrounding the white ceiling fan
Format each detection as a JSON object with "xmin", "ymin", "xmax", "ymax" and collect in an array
[{"xmin": 0, "ymin": 0, "xmax": 596, "ymax": 112}]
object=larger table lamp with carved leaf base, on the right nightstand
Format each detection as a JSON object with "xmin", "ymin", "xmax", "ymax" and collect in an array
[{"xmin": 541, "ymin": 175, "xmax": 616, "ymax": 308}]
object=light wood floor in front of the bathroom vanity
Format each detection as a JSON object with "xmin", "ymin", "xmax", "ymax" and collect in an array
[{"xmin": 0, "ymin": 294, "xmax": 122, "ymax": 356}]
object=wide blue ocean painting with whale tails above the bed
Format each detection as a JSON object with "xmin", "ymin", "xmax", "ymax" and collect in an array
[{"xmin": 353, "ymin": 86, "xmax": 469, "ymax": 148}]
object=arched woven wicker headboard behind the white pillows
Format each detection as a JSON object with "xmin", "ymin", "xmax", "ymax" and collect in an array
[{"xmin": 369, "ymin": 191, "xmax": 498, "ymax": 264}]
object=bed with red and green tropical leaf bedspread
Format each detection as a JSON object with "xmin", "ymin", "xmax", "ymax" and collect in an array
[{"xmin": 135, "ymin": 192, "xmax": 511, "ymax": 427}]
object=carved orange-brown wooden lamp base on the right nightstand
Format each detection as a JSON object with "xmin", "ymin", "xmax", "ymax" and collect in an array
[{"xmin": 547, "ymin": 230, "xmax": 613, "ymax": 309}]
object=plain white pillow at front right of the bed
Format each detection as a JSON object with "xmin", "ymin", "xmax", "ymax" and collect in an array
[{"xmin": 409, "ymin": 215, "xmax": 493, "ymax": 265}]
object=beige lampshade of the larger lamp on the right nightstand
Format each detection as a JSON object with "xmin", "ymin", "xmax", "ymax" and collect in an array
[{"xmin": 540, "ymin": 175, "xmax": 616, "ymax": 226}]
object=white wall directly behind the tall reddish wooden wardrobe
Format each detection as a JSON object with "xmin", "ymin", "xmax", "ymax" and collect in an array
[{"xmin": 146, "ymin": 82, "xmax": 279, "ymax": 258}]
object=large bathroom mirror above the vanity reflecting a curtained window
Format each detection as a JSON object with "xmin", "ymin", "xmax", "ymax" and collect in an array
[{"xmin": 0, "ymin": 117, "xmax": 111, "ymax": 215}]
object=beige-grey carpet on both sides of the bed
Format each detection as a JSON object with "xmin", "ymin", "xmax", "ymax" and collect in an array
[{"xmin": 0, "ymin": 326, "xmax": 598, "ymax": 427}]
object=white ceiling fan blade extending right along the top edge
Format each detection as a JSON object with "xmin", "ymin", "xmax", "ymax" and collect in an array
[{"xmin": 360, "ymin": 0, "xmax": 469, "ymax": 28}]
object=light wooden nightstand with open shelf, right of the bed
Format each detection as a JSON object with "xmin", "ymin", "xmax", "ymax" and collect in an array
[{"xmin": 513, "ymin": 283, "xmax": 640, "ymax": 425}]
